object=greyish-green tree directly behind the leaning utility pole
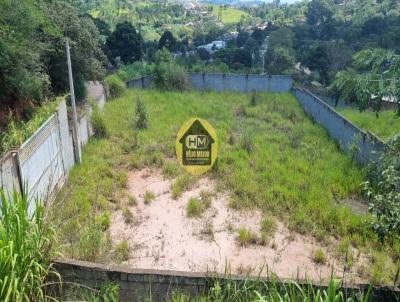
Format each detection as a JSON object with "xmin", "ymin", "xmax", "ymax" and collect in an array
[{"xmin": 43, "ymin": 1, "xmax": 105, "ymax": 100}]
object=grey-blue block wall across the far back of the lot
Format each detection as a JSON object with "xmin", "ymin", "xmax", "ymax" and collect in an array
[{"xmin": 126, "ymin": 72, "xmax": 293, "ymax": 92}]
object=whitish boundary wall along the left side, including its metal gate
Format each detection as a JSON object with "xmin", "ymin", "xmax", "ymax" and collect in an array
[{"xmin": 0, "ymin": 82, "xmax": 106, "ymax": 201}]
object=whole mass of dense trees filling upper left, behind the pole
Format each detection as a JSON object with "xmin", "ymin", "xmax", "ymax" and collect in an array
[{"xmin": 0, "ymin": 0, "xmax": 105, "ymax": 127}]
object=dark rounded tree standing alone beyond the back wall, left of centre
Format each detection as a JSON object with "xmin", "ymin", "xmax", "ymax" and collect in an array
[{"xmin": 106, "ymin": 22, "xmax": 143, "ymax": 64}]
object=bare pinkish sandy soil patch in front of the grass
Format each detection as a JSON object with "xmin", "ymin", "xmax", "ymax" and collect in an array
[{"xmin": 110, "ymin": 168, "xmax": 361, "ymax": 282}]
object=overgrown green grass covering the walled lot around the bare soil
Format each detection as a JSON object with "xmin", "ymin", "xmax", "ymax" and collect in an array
[{"xmin": 51, "ymin": 90, "xmax": 400, "ymax": 283}]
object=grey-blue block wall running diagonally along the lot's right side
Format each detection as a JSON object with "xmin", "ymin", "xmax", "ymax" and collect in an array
[{"xmin": 293, "ymin": 88, "xmax": 385, "ymax": 165}]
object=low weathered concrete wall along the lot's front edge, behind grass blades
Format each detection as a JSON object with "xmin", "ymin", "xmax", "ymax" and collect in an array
[{"xmin": 54, "ymin": 259, "xmax": 400, "ymax": 302}]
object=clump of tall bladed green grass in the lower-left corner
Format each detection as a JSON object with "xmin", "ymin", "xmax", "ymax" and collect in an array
[{"xmin": 0, "ymin": 190, "xmax": 56, "ymax": 302}]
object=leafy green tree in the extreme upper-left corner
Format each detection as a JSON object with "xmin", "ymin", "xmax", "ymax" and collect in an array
[{"xmin": 0, "ymin": 1, "xmax": 49, "ymax": 108}]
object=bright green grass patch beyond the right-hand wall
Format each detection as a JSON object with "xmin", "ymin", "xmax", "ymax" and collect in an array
[{"xmin": 336, "ymin": 108, "xmax": 400, "ymax": 141}]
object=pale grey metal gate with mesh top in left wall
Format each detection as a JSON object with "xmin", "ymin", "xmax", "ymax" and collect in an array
[{"xmin": 18, "ymin": 114, "xmax": 64, "ymax": 213}]
